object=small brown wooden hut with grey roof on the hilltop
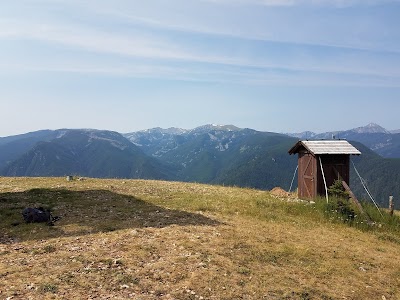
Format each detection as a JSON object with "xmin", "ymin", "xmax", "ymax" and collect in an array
[{"xmin": 289, "ymin": 140, "xmax": 361, "ymax": 199}]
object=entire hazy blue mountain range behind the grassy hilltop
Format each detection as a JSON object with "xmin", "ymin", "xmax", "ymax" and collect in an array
[{"xmin": 0, "ymin": 124, "xmax": 400, "ymax": 203}]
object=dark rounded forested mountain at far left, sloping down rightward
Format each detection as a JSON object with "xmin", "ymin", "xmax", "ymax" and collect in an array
[{"xmin": 0, "ymin": 129, "xmax": 168, "ymax": 179}]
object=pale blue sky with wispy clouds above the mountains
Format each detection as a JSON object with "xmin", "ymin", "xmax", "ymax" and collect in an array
[{"xmin": 0, "ymin": 0, "xmax": 400, "ymax": 137}]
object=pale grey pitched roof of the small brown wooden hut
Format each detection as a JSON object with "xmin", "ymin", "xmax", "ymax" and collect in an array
[{"xmin": 289, "ymin": 140, "xmax": 361, "ymax": 155}]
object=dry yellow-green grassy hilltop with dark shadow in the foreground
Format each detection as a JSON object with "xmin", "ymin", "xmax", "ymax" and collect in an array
[{"xmin": 0, "ymin": 177, "xmax": 400, "ymax": 299}]
